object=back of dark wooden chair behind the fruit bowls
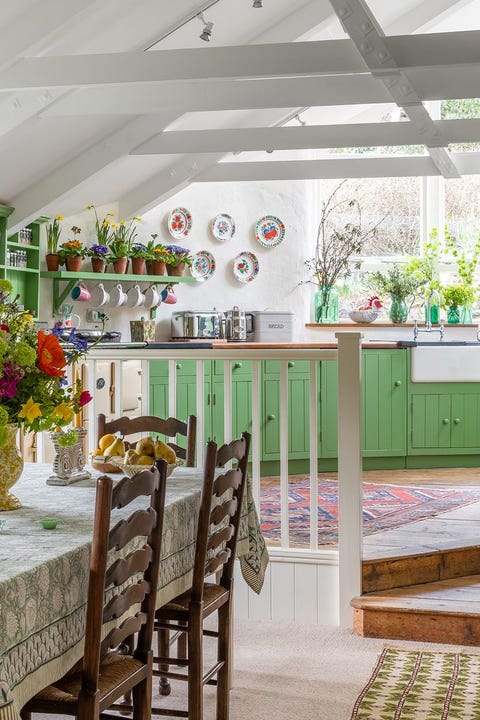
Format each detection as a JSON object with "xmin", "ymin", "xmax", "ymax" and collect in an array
[{"xmin": 97, "ymin": 413, "xmax": 197, "ymax": 467}]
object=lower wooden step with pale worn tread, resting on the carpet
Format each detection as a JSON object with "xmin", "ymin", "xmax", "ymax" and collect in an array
[{"xmin": 351, "ymin": 574, "xmax": 480, "ymax": 646}]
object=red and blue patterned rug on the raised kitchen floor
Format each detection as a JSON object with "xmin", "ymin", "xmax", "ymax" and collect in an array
[{"xmin": 260, "ymin": 478, "xmax": 480, "ymax": 544}]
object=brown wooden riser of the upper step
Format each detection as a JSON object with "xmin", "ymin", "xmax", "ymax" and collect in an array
[{"xmin": 362, "ymin": 545, "xmax": 480, "ymax": 593}]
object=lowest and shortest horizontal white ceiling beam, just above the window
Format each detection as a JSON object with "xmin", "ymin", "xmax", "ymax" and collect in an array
[{"xmin": 195, "ymin": 155, "xmax": 440, "ymax": 182}]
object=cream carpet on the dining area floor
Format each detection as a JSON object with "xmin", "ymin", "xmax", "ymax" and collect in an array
[{"xmin": 33, "ymin": 621, "xmax": 480, "ymax": 720}]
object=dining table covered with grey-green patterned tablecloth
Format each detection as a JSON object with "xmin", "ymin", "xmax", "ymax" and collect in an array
[{"xmin": 0, "ymin": 463, "xmax": 268, "ymax": 720}]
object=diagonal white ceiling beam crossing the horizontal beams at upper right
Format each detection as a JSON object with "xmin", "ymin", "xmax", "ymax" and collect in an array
[{"xmin": 330, "ymin": 0, "xmax": 460, "ymax": 178}]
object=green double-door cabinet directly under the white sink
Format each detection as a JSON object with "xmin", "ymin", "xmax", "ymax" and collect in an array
[{"xmin": 409, "ymin": 383, "xmax": 480, "ymax": 455}]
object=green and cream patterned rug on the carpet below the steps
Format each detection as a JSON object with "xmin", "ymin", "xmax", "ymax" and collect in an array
[{"xmin": 351, "ymin": 648, "xmax": 480, "ymax": 720}]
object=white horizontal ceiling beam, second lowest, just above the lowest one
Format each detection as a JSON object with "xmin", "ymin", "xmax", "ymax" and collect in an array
[{"xmin": 130, "ymin": 119, "xmax": 480, "ymax": 155}]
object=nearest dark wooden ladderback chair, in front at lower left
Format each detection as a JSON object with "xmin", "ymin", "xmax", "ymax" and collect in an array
[{"xmin": 21, "ymin": 460, "xmax": 167, "ymax": 720}]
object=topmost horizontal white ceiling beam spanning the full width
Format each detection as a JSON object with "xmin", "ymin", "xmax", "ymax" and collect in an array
[{"xmin": 0, "ymin": 30, "xmax": 480, "ymax": 91}]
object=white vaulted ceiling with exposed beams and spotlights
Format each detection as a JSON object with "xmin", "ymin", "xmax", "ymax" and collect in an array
[{"xmin": 0, "ymin": 0, "xmax": 480, "ymax": 230}]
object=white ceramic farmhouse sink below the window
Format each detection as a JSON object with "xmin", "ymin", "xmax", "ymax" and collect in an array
[{"xmin": 411, "ymin": 343, "xmax": 480, "ymax": 382}]
